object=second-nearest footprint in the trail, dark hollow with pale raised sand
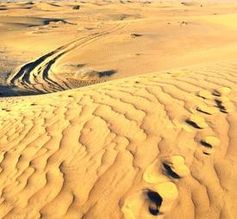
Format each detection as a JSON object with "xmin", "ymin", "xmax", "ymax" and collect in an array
[{"xmin": 163, "ymin": 155, "xmax": 190, "ymax": 179}]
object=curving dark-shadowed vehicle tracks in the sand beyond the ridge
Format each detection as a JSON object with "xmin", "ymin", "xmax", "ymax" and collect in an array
[{"xmin": 7, "ymin": 24, "xmax": 127, "ymax": 93}]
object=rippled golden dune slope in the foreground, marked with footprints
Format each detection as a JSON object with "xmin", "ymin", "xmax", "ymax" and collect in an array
[{"xmin": 0, "ymin": 62, "xmax": 237, "ymax": 219}]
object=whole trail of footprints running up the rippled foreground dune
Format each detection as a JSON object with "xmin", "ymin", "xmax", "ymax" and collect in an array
[{"xmin": 122, "ymin": 87, "xmax": 234, "ymax": 219}]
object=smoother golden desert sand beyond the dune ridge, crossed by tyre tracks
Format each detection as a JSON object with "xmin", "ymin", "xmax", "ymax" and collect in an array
[{"xmin": 0, "ymin": 0, "xmax": 237, "ymax": 96}]
